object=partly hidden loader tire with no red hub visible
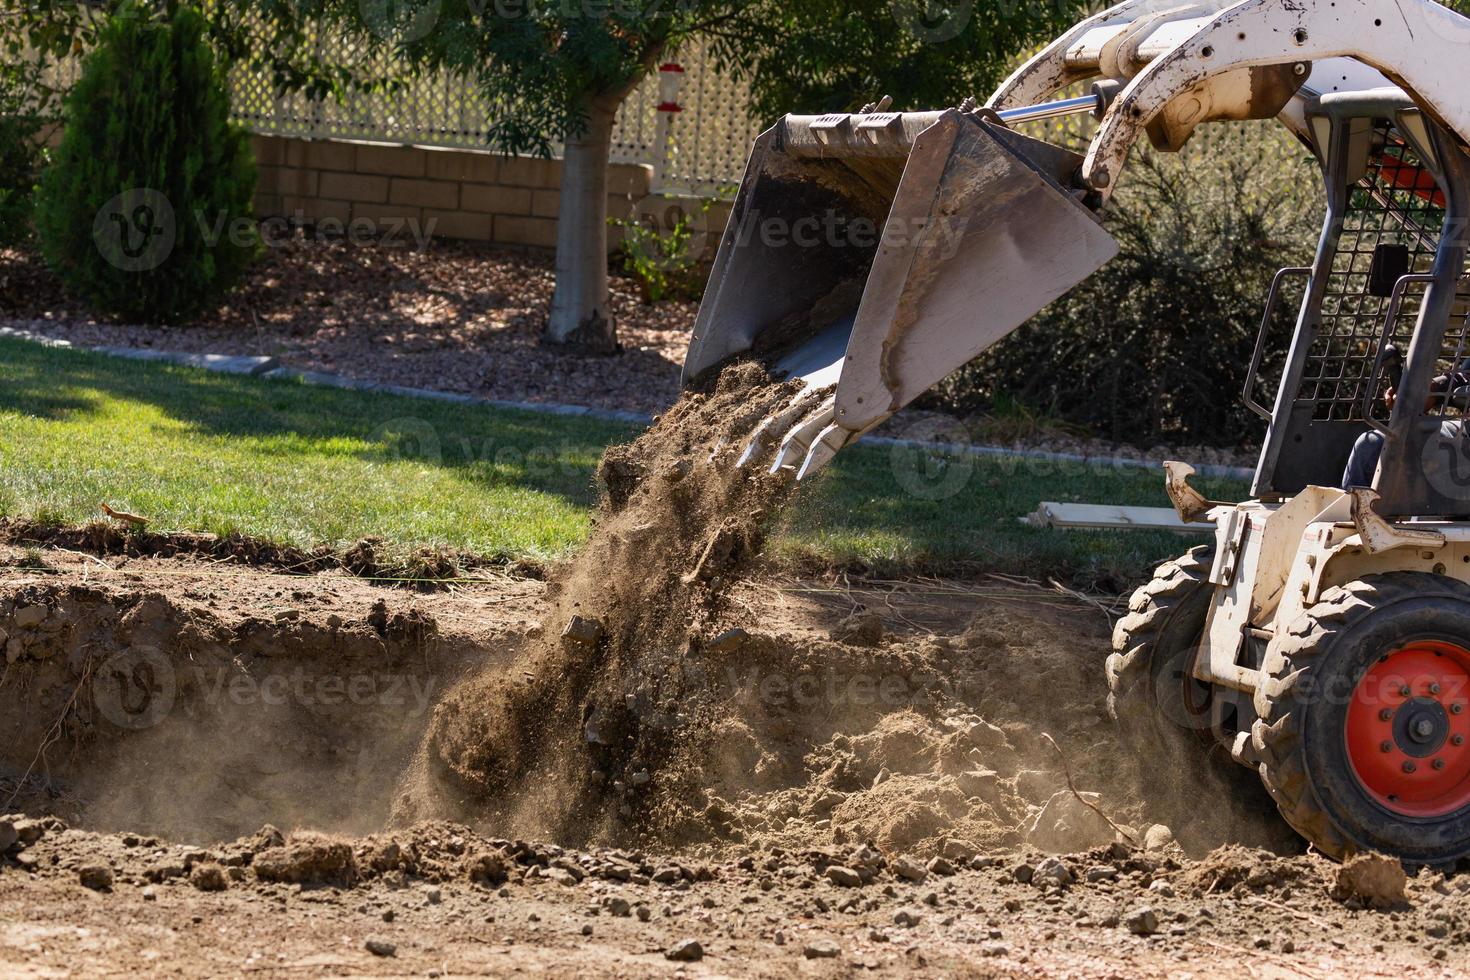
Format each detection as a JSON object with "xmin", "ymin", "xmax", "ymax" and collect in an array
[{"xmin": 1107, "ymin": 545, "xmax": 1214, "ymax": 742}]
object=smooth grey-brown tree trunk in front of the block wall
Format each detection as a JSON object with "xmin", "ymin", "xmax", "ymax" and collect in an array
[{"xmin": 542, "ymin": 100, "xmax": 617, "ymax": 354}]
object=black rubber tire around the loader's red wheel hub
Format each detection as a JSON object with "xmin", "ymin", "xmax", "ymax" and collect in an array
[{"xmin": 1251, "ymin": 572, "xmax": 1470, "ymax": 865}]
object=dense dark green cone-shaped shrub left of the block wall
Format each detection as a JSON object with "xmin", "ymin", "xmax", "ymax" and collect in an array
[{"xmin": 35, "ymin": 4, "xmax": 257, "ymax": 322}]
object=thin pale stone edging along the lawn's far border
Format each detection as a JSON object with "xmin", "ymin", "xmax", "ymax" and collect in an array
[{"xmin": 0, "ymin": 326, "xmax": 1255, "ymax": 480}]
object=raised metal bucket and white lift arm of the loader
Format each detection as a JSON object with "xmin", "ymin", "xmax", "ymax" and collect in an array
[{"xmin": 684, "ymin": 0, "xmax": 1470, "ymax": 479}]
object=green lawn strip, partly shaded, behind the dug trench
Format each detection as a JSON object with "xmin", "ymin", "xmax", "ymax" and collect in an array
[{"xmin": 0, "ymin": 338, "xmax": 1244, "ymax": 586}]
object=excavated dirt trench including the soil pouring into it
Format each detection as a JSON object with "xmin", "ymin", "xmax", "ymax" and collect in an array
[{"xmin": 0, "ymin": 366, "xmax": 1299, "ymax": 855}]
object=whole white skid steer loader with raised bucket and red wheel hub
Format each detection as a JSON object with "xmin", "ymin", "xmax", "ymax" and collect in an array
[{"xmin": 684, "ymin": 0, "xmax": 1470, "ymax": 864}]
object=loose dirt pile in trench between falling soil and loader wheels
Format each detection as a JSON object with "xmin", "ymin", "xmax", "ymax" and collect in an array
[{"xmin": 643, "ymin": 605, "xmax": 1301, "ymax": 860}]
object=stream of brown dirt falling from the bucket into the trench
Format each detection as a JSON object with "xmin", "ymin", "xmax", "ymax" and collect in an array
[{"xmin": 400, "ymin": 364, "xmax": 792, "ymax": 839}]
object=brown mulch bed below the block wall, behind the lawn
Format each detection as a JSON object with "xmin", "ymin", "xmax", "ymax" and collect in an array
[{"xmin": 0, "ymin": 238, "xmax": 698, "ymax": 414}]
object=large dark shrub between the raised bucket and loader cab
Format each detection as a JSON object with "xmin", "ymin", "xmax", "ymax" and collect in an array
[{"xmin": 923, "ymin": 123, "xmax": 1323, "ymax": 445}]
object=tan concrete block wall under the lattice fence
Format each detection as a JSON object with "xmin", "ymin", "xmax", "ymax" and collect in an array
[{"xmin": 254, "ymin": 135, "xmax": 661, "ymax": 248}]
